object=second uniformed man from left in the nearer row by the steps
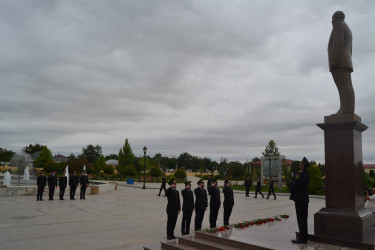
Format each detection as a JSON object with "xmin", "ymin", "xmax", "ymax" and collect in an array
[{"xmin": 181, "ymin": 181, "xmax": 194, "ymax": 235}]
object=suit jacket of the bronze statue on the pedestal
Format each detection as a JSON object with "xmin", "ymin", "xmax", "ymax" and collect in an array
[{"xmin": 328, "ymin": 20, "xmax": 353, "ymax": 72}]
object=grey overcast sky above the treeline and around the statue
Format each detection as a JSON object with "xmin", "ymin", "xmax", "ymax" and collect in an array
[{"xmin": 0, "ymin": 0, "xmax": 375, "ymax": 164}]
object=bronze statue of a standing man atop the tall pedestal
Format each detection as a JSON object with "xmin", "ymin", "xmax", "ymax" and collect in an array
[{"xmin": 328, "ymin": 11, "xmax": 355, "ymax": 115}]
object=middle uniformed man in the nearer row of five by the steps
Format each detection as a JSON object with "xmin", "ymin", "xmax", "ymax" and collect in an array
[{"xmin": 194, "ymin": 179, "xmax": 208, "ymax": 231}]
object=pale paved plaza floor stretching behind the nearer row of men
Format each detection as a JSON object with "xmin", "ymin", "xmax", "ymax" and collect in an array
[{"xmin": 0, "ymin": 177, "xmax": 325, "ymax": 249}]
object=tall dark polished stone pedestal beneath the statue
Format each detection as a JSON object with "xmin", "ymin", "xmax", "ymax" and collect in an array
[{"xmin": 314, "ymin": 120, "xmax": 375, "ymax": 244}]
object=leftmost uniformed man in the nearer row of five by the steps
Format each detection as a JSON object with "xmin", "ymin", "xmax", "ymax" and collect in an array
[{"xmin": 166, "ymin": 179, "xmax": 181, "ymax": 240}]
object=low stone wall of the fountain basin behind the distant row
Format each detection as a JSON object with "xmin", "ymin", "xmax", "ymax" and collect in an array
[{"xmin": 0, "ymin": 181, "xmax": 117, "ymax": 197}]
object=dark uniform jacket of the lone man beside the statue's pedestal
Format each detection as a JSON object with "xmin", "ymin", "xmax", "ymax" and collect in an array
[{"xmin": 290, "ymin": 170, "xmax": 310, "ymax": 203}]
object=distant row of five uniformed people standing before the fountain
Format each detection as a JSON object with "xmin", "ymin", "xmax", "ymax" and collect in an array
[{"xmin": 36, "ymin": 170, "xmax": 89, "ymax": 201}]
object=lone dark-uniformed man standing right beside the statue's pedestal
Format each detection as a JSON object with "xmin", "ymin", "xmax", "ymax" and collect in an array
[{"xmin": 290, "ymin": 157, "xmax": 310, "ymax": 244}]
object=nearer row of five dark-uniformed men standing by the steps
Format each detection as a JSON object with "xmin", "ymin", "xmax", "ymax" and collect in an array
[{"xmin": 166, "ymin": 179, "xmax": 234, "ymax": 240}]
